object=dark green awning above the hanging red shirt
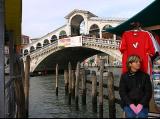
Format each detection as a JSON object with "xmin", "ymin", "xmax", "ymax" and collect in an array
[{"xmin": 105, "ymin": 0, "xmax": 160, "ymax": 35}]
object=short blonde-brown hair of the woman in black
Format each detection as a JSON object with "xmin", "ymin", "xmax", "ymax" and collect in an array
[{"xmin": 126, "ymin": 55, "xmax": 141, "ymax": 71}]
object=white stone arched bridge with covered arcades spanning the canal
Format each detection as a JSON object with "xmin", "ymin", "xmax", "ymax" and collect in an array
[{"xmin": 23, "ymin": 9, "xmax": 125, "ymax": 72}]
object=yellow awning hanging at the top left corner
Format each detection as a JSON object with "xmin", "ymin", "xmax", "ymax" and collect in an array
[{"xmin": 5, "ymin": 0, "xmax": 22, "ymax": 44}]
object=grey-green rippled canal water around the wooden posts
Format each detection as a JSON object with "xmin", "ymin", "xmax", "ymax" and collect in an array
[{"xmin": 29, "ymin": 68, "xmax": 122, "ymax": 118}]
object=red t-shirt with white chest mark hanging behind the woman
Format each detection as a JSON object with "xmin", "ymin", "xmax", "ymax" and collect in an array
[{"xmin": 119, "ymin": 30, "xmax": 155, "ymax": 74}]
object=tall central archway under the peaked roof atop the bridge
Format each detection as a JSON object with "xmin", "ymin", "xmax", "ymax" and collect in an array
[{"xmin": 71, "ymin": 15, "xmax": 85, "ymax": 36}]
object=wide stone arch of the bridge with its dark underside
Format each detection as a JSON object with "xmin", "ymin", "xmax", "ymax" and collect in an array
[{"xmin": 31, "ymin": 46, "xmax": 120, "ymax": 72}]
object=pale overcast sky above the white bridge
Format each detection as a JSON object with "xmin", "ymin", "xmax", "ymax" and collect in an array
[{"xmin": 22, "ymin": 0, "xmax": 154, "ymax": 38}]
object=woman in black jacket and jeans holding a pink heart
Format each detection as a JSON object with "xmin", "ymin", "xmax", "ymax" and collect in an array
[{"xmin": 119, "ymin": 55, "xmax": 152, "ymax": 118}]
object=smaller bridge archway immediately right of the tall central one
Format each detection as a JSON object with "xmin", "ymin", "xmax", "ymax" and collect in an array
[{"xmin": 89, "ymin": 24, "xmax": 100, "ymax": 38}]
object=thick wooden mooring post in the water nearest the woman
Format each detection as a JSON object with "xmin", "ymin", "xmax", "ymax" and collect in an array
[{"xmin": 107, "ymin": 72, "xmax": 116, "ymax": 118}]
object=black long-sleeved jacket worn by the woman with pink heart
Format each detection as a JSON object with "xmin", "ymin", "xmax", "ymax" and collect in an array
[{"xmin": 119, "ymin": 71, "xmax": 152, "ymax": 108}]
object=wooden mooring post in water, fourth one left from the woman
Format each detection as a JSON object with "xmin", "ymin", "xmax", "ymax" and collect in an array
[{"xmin": 81, "ymin": 68, "xmax": 86, "ymax": 105}]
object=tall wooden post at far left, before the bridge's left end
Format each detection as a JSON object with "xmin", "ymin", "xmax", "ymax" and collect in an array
[{"xmin": 24, "ymin": 55, "xmax": 31, "ymax": 117}]
